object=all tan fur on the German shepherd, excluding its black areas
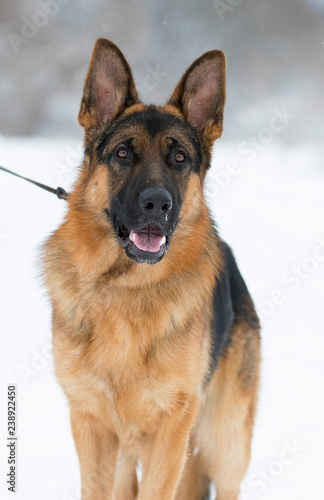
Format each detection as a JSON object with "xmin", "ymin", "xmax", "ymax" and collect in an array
[{"xmin": 44, "ymin": 42, "xmax": 259, "ymax": 500}]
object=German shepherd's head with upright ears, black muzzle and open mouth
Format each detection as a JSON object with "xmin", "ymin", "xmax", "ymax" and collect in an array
[{"xmin": 75, "ymin": 38, "xmax": 225, "ymax": 264}]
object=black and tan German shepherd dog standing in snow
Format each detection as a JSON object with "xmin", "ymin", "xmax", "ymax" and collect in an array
[{"xmin": 43, "ymin": 38, "xmax": 260, "ymax": 500}]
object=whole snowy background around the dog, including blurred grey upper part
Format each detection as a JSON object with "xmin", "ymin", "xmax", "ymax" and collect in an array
[{"xmin": 0, "ymin": 0, "xmax": 324, "ymax": 500}]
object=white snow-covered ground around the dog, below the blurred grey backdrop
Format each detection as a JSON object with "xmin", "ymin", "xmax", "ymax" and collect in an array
[{"xmin": 0, "ymin": 134, "xmax": 324, "ymax": 500}]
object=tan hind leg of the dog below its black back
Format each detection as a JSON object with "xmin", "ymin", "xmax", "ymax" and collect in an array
[{"xmin": 177, "ymin": 324, "xmax": 260, "ymax": 500}]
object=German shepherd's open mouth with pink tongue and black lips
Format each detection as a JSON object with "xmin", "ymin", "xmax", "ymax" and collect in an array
[{"xmin": 116, "ymin": 220, "xmax": 170, "ymax": 264}]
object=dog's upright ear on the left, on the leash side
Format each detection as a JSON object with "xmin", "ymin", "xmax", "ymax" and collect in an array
[{"xmin": 79, "ymin": 38, "xmax": 140, "ymax": 132}]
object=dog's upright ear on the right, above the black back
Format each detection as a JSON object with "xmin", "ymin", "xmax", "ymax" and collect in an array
[{"xmin": 169, "ymin": 50, "xmax": 226, "ymax": 144}]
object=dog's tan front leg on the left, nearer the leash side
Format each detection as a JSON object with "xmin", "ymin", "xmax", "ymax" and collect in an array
[{"xmin": 71, "ymin": 408, "xmax": 118, "ymax": 500}]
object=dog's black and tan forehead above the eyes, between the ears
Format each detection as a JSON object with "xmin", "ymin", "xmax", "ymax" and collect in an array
[{"xmin": 98, "ymin": 106, "xmax": 200, "ymax": 155}]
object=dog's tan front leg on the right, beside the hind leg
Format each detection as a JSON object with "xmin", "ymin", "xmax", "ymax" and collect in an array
[{"xmin": 138, "ymin": 397, "xmax": 199, "ymax": 500}]
